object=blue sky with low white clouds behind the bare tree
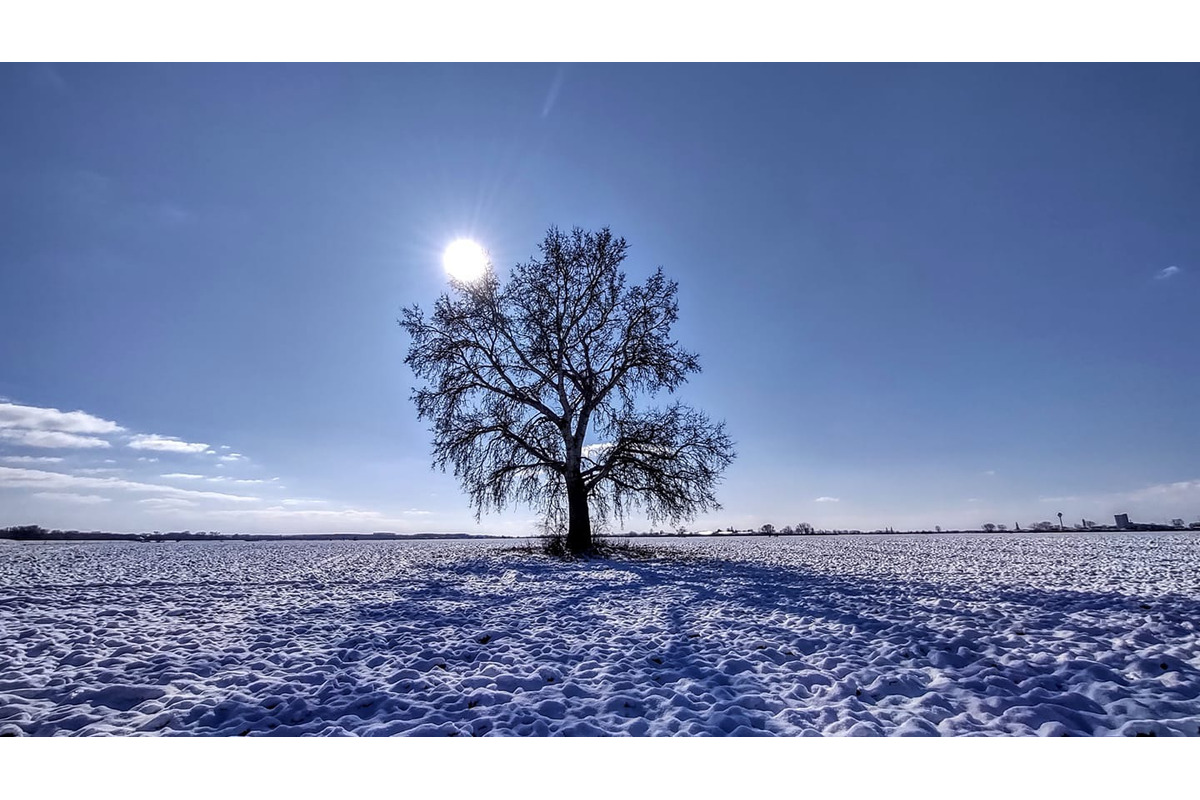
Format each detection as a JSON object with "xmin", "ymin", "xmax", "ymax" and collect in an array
[{"xmin": 0, "ymin": 65, "xmax": 1200, "ymax": 533}]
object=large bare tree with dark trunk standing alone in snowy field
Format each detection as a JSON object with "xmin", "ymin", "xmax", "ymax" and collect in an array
[{"xmin": 400, "ymin": 221, "xmax": 734, "ymax": 553}]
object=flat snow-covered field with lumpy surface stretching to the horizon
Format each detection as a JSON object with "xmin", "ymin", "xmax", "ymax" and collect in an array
[{"xmin": 0, "ymin": 534, "xmax": 1200, "ymax": 735}]
